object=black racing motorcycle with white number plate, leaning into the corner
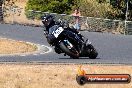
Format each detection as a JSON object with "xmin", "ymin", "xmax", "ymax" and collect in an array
[{"xmin": 44, "ymin": 21, "xmax": 98, "ymax": 59}]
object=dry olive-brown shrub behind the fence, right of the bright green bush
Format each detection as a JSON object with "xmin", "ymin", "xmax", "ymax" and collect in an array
[{"xmin": 80, "ymin": 0, "xmax": 117, "ymax": 18}]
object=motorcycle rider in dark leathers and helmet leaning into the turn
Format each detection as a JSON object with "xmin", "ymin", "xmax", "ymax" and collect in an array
[{"xmin": 42, "ymin": 14, "xmax": 83, "ymax": 53}]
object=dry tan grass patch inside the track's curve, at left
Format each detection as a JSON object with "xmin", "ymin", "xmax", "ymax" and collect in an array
[{"xmin": 0, "ymin": 39, "xmax": 37, "ymax": 54}]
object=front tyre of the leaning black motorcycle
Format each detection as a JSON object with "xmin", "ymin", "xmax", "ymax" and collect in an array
[{"xmin": 60, "ymin": 42, "xmax": 79, "ymax": 59}]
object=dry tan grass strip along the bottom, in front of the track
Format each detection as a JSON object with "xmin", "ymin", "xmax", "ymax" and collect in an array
[{"xmin": 0, "ymin": 64, "xmax": 132, "ymax": 88}]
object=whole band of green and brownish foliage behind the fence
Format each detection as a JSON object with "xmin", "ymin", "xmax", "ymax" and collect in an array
[{"xmin": 26, "ymin": 0, "xmax": 132, "ymax": 20}]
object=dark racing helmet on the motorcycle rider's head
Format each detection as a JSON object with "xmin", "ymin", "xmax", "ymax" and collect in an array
[{"xmin": 42, "ymin": 14, "xmax": 54, "ymax": 27}]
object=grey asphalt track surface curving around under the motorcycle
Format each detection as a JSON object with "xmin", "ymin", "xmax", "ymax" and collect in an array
[{"xmin": 0, "ymin": 24, "xmax": 132, "ymax": 64}]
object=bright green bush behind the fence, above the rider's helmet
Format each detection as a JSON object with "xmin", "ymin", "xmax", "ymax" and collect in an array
[{"xmin": 26, "ymin": 0, "xmax": 78, "ymax": 14}]
